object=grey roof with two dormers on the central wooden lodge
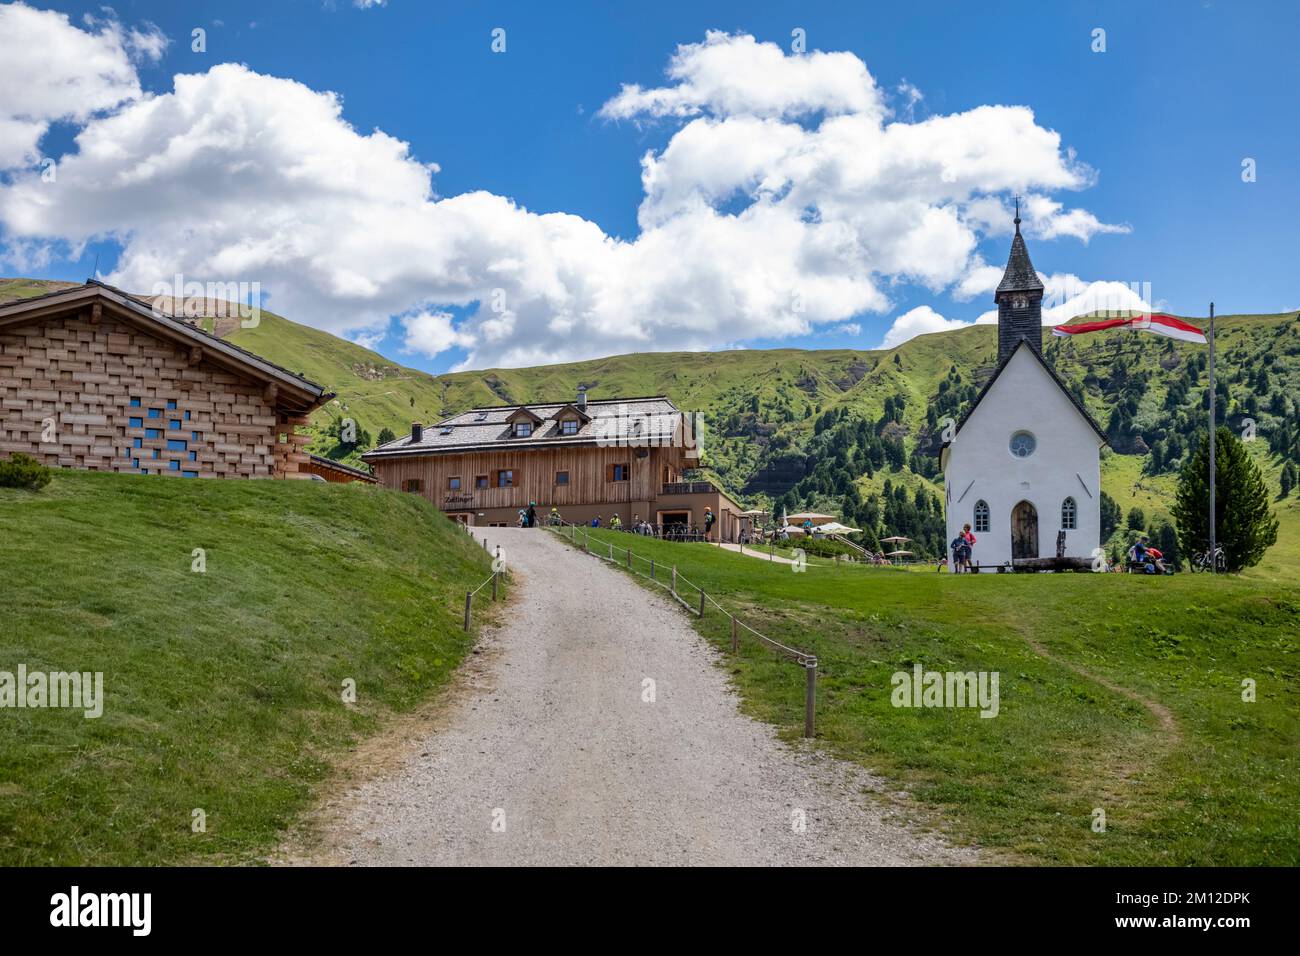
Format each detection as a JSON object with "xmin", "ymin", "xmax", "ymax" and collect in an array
[{"xmin": 361, "ymin": 395, "xmax": 681, "ymax": 462}]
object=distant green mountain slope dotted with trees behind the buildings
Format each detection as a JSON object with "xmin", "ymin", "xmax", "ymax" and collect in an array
[{"xmin": 0, "ymin": 280, "xmax": 1300, "ymax": 553}]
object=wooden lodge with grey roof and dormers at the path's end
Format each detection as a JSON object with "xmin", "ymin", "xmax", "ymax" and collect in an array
[{"xmin": 363, "ymin": 388, "xmax": 746, "ymax": 541}]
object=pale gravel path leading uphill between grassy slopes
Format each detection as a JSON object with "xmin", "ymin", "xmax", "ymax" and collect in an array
[{"xmin": 287, "ymin": 528, "xmax": 976, "ymax": 865}]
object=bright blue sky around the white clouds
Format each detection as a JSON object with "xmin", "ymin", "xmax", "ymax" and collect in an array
[{"xmin": 0, "ymin": 0, "xmax": 1300, "ymax": 371}]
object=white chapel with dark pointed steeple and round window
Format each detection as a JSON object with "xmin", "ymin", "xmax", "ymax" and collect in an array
[{"xmin": 940, "ymin": 213, "xmax": 1106, "ymax": 571}]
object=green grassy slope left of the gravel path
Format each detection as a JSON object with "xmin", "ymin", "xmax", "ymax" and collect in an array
[{"xmin": 0, "ymin": 472, "xmax": 490, "ymax": 865}]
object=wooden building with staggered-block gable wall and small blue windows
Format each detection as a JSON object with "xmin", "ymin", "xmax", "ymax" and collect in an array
[{"xmin": 0, "ymin": 281, "xmax": 333, "ymax": 479}]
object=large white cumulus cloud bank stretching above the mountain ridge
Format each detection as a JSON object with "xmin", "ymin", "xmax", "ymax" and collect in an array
[{"xmin": 0, "ymin": 26, "xmax": 1133, "ymax": 367}]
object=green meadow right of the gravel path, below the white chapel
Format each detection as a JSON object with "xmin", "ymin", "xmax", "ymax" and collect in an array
[{"xmin": 566, "ymin": 531, "xmax": 1300, "ymax": 866}]
